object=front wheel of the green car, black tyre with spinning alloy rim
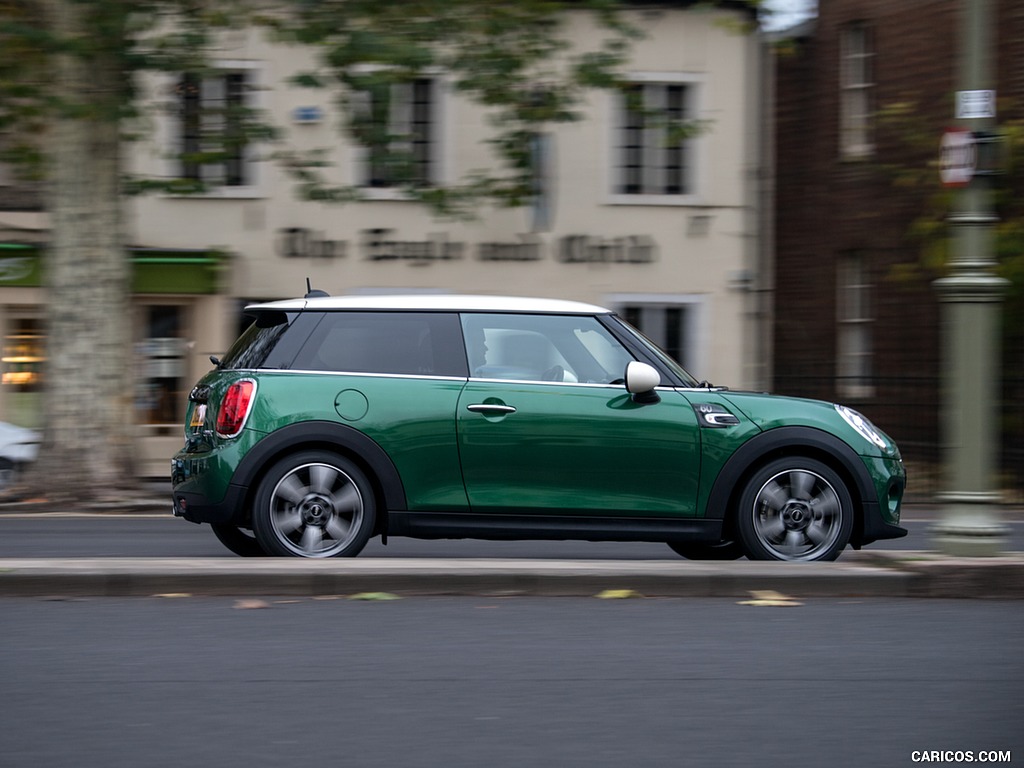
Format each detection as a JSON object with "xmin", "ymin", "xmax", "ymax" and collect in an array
[{"xmin": 736, "ymin": 457, "xmax": 854, "ymax": 561}]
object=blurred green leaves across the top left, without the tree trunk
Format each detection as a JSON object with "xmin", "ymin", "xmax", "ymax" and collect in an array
[{"xmin": 0, "ymin": 0, "xmax": 760, "ymax": 215}]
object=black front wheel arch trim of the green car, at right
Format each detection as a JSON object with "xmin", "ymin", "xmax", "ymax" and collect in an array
[{"xmin": 706, "ymin": 427, "xmax": 879, "ymax": 549}]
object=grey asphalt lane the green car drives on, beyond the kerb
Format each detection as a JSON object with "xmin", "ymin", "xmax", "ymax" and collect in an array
[{"xmin": 0, "ymin": 508, "xmax": 1024, "ymax": 560}]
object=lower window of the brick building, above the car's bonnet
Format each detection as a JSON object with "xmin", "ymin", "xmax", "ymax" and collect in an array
[{"xmin": 836, "ymin": 253, "xmax": 874, "ymax": 398}]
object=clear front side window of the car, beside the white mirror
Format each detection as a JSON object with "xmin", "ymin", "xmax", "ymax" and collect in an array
[{"xmin": 462, "ymin": 313, "xmax": 633, "ymax": 384}]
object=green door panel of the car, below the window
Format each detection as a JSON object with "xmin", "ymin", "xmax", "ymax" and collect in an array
[{"xmin": 457, "ymin": 381, "xmax": 700, "ymax": 516}]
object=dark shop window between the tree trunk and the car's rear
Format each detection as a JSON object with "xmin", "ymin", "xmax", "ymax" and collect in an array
[{"xmin": 136, "ymin": 305, "xmax": 186, "ymax": 425}]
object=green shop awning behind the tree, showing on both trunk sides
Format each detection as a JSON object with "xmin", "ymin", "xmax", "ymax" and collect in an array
[{"xmin": 0, "ymin": 243, "xmax": 227, "ymax": 294}]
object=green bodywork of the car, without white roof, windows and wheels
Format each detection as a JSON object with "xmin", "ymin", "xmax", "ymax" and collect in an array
[{"xmin": 172, "ymin": 294, "xmax": 905, "ymax": 561}]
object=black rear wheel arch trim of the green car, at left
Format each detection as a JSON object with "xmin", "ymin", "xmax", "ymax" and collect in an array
[{"xmin": 231, "ymin": 421, "xmax": 407, "ymax": 534}]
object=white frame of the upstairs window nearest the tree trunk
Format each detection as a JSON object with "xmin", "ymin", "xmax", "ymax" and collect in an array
[{"xmin": 158, "ymin": 58, "xmax": 266, "ymax": 199}]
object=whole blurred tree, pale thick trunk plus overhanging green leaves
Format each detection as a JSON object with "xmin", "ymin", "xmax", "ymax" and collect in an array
[{"xmin": 0, "ymin": 0, "xmax": 757, "ymax": 503}]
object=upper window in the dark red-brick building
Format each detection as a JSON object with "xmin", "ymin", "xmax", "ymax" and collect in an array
[{"xmin": 840, "ymin": 23, "xmax": 874, "ymax": 158}]
